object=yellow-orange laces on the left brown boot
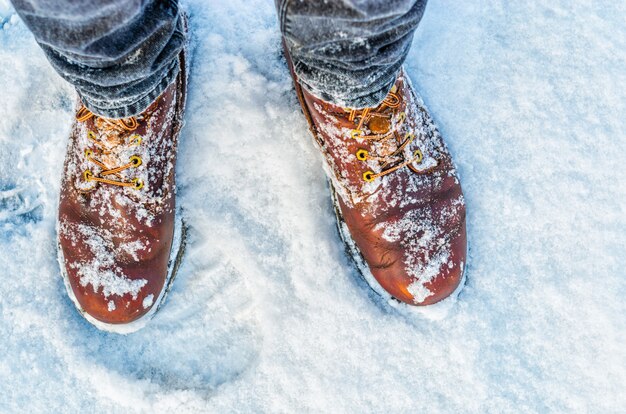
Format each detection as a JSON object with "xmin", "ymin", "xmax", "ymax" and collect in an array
[{"xmin": 76, "ymin": 106, "xmax": 143, "ymax": 191}]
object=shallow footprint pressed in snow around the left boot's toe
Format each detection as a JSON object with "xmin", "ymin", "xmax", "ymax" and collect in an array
[{"xmin": 67, "ymin": 229, "xmax": 262, "ymax": 399}]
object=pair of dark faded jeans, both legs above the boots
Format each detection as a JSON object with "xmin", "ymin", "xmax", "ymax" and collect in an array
[{"xmin": 12, "ymin": 0, "xmax": 426, "ymax": 118}]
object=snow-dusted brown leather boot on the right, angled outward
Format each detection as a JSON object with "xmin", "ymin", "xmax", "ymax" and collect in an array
[{"xmin": 287, "ymin": 51, "xmax": 467, "ymax": 305}]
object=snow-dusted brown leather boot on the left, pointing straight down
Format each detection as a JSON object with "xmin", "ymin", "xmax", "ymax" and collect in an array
[{"xmin": 58, "ymin": 52, "xmax": 186, "ymax": 333}]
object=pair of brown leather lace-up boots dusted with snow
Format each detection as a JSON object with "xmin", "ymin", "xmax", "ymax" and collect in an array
[{"xmin": 58, "ymin": 44, "xmax": 466, "ymax": 333}]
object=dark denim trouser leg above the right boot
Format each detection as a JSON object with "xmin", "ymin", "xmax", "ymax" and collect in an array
[{"xmin": 276, "ymin": 0, "xmax": 427, "ymax": 108}]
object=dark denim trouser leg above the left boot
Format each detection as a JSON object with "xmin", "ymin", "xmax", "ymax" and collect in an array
[{"xmin": 12, "ymin": 0, "xmax": 184, "ymax": 118}]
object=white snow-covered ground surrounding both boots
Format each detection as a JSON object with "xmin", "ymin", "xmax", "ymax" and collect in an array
[{"xmin": 0, "ymin": 0, "xmax": 626, "ymax": 413}]
